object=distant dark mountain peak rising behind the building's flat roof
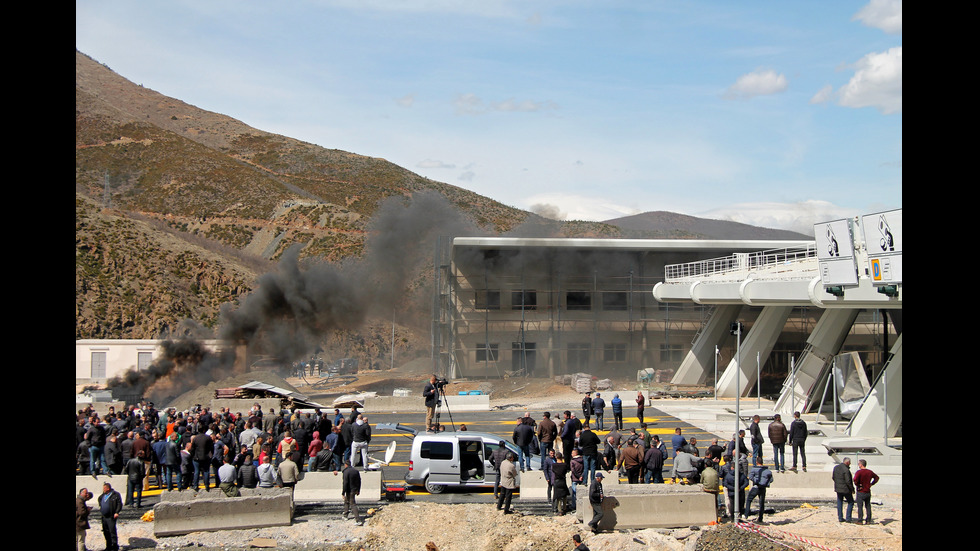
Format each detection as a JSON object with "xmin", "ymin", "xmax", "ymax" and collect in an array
[{"xmin": 605, "ymin": 211, "xmax": 813, "ymax": 240}]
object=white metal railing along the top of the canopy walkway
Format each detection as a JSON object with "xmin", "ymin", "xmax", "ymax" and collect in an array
[{"xmin": 664, "ymin": 245, "xmax": 817, "ymax": 281}]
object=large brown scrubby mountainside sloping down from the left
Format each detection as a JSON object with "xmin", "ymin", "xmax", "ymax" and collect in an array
[{"xmin": 75, "ymin": 50, "xmax": 812, "ymax": 366}]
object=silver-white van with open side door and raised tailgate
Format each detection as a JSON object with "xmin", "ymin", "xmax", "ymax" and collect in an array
[{"xmin": 378, "ymin": 424, "xmax": 541, "ymax": 494}]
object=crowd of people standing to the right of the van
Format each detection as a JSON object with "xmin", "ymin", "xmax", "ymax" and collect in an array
[{"xmin": 506, "ymin": 392, "xmax": 878, "ymax": 531}]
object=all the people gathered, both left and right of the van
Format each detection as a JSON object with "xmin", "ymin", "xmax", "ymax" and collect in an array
[{"xmin": 75, "ymin": 390, "xmax": 878, "ymax": 549}]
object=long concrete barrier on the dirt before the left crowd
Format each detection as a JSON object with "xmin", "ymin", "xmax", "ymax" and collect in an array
[{"xmin": 153, "ymin": 488, "xmax": 293, "ymax": 536}]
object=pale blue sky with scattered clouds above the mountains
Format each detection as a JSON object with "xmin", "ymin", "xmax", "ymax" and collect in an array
[{"xmin": 75, "ymin": 0, "xmax": 902, "ymax": 234}]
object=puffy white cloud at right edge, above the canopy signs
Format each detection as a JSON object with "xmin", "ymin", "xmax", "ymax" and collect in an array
[{"xmin": 838, "ymin": 46, "xmax": 902, "ymax": 115}]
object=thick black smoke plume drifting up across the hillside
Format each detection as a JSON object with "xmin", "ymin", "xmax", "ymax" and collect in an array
[{"xmin": 108, "ymin": 192, "xmax": 483, "ymax": 404}]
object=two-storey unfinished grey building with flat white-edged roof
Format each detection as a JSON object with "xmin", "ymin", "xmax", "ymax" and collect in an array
[{"xmin": 433, "ymin": 237, "xmax": 889, "ymax": 402}]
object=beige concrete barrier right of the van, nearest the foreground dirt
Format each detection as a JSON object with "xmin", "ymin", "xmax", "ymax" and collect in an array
[{"xmin": 576, "ymin": 482, "xmax": 718, "ymax": 530}]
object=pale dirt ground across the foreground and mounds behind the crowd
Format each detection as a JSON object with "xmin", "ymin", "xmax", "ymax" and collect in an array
[{"xmin": 87, "ymin": 370, "xmax": 902, "ymax": 551}]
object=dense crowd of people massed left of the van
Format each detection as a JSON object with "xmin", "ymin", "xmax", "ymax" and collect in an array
[{"xmin": 75, "ymin": 403, "xmax": 371, "ymax": 496}]
